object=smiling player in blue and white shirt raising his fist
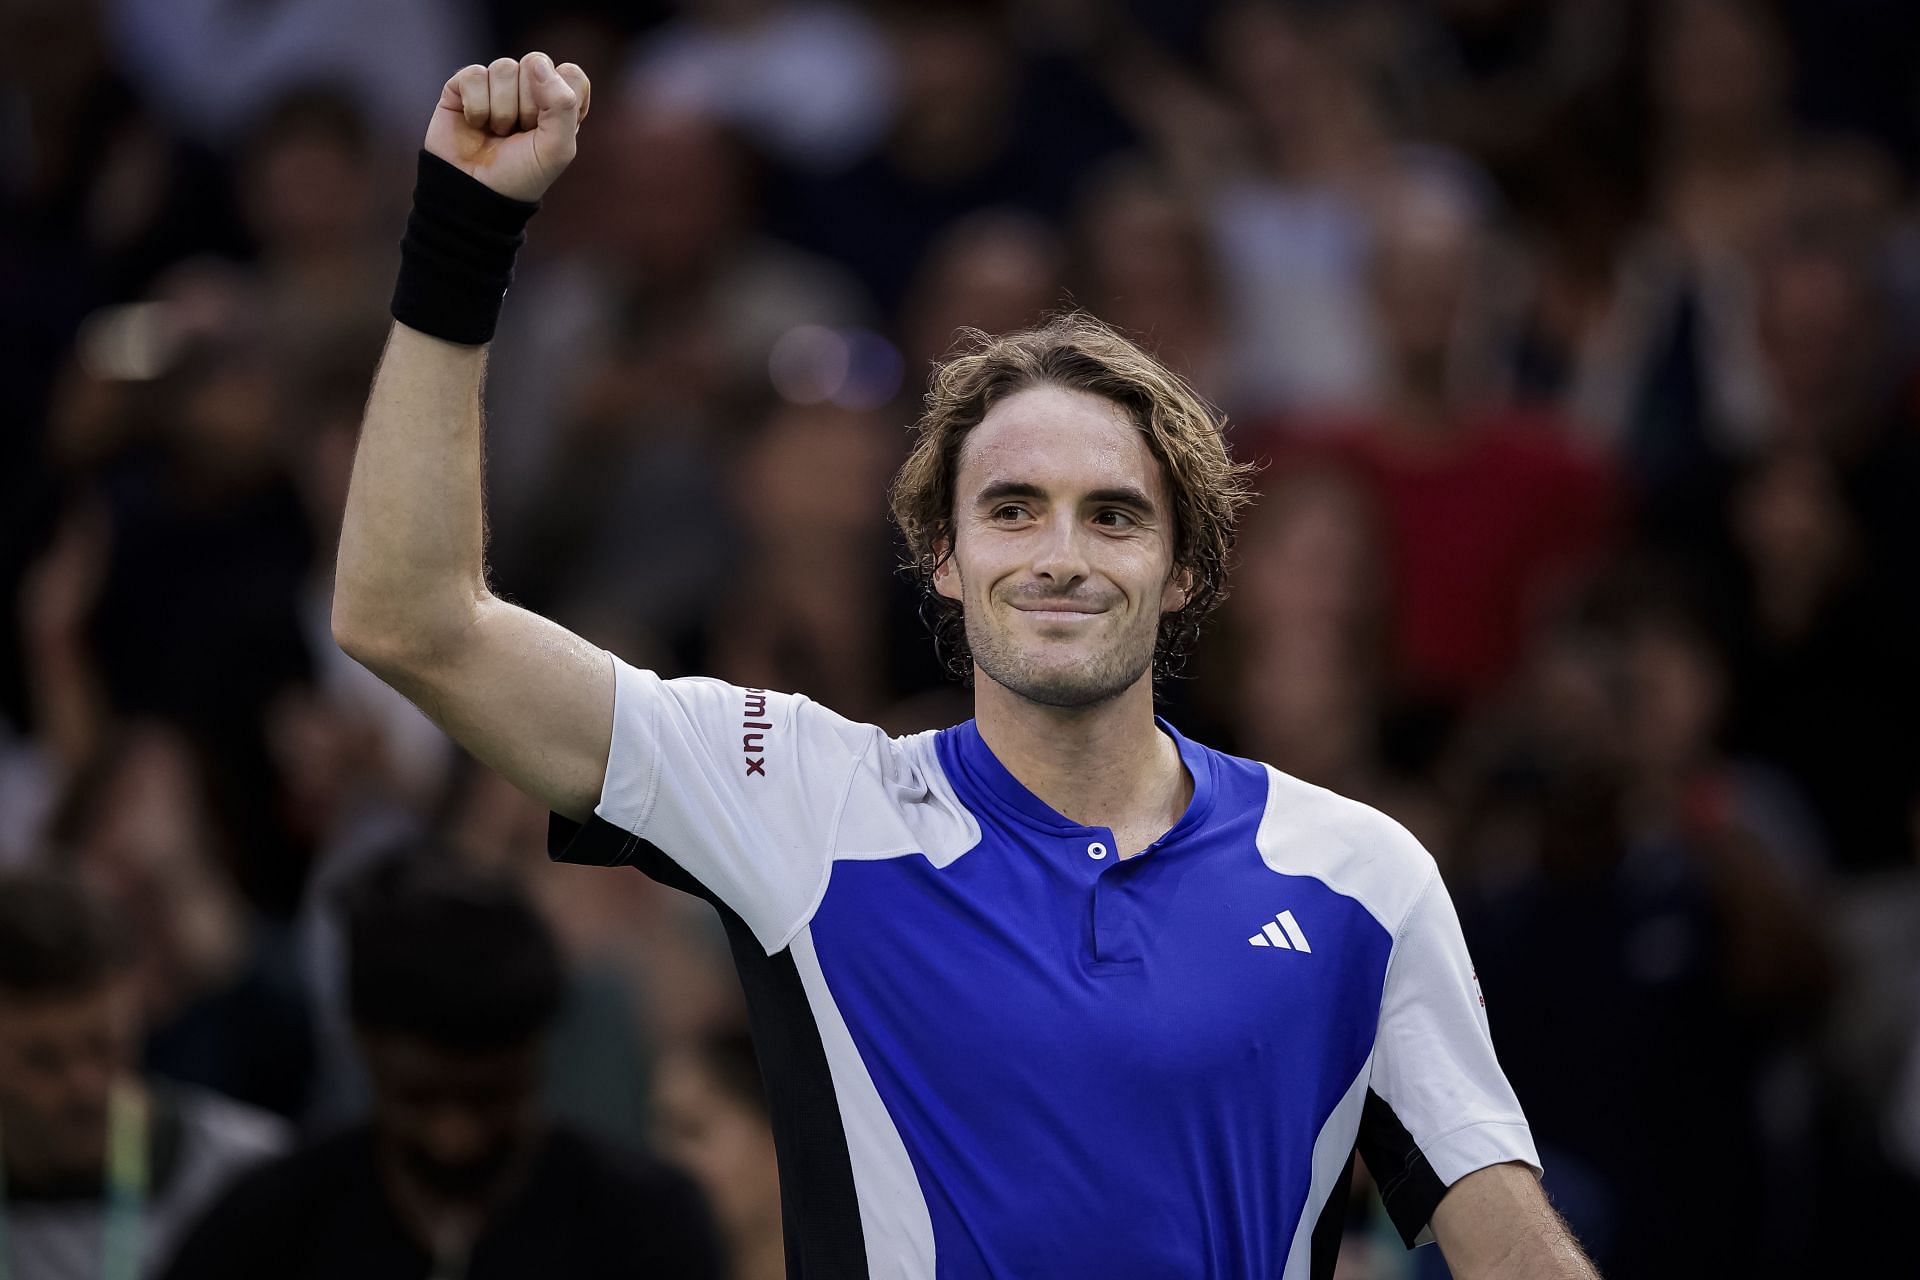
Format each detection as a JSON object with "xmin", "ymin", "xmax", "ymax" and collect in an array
[{"xmin": 334, "ymin": 54, "xmax": 1594, "ymax": 1280}]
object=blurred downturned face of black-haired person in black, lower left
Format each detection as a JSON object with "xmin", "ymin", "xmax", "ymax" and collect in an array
[{"xmin": 361, "ymin": 1032, "xmax": 540, "ymax": 1205}]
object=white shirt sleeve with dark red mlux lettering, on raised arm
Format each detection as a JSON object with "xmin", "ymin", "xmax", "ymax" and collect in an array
[{"xmin": 555, "ymin": 658, "xmax": 887, "ymax": 952}]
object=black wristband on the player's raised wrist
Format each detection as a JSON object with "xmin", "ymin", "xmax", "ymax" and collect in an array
[{"xmin": 394, "ymin": 150, "xmax": 540, "ymax": 345}]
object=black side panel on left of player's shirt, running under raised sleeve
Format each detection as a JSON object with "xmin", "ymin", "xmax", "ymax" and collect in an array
[{"xmin": 547, "ymin": 814, "xmax": 868, "ymax": 1280}]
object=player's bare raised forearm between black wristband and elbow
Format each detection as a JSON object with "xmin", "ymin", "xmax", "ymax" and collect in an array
[{"xmin": 334, "ymin": 324, "xmax": 486, "ymax": 660}]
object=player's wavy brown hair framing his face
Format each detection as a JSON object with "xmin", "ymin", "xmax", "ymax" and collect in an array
[{"xmin": 891, "ymin": 311, "xmax": 1256, "ymax": 679}]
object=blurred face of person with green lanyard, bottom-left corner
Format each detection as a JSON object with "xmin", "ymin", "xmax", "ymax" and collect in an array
[{"xmin": 0, "ymin": 981, "xmax": 138, "ymax": 1178}]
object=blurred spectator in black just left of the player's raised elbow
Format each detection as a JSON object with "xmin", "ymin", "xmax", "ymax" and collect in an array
[{"xmin": 63, "ymin": 334, "xmax": 313, "ymax": 915}]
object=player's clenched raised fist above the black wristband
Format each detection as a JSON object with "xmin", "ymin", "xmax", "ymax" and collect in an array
[{"xmin": 426, "ymin": 54, "xmax": 593, "ymax": 201}]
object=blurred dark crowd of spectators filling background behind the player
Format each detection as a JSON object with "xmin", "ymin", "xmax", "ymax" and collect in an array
[{"xmin": 0, "ymin": 0, "xmax": 1920, "ymax": 1280}]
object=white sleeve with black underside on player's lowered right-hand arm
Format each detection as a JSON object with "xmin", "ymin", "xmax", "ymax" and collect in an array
[{"xmin": 1359, "ymin": 869, "xmax": 1540, "ymax": 1247}]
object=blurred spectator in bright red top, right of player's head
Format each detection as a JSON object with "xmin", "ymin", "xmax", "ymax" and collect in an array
[{"xmin": 1288, "ymin": 175, "xmax": 1619, "ymax": 708}]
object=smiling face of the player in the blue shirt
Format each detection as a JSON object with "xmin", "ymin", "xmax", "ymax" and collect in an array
[{"xmin": 933, "ymin": 386, "xmax": 1187, "ymax": 706}]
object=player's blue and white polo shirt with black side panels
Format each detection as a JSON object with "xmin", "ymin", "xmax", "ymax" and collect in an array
[{"xmin": 553, "ymin": 658, "xmax": 1538, "ymax": 1280}]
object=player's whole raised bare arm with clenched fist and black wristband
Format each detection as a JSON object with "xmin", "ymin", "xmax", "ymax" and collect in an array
[{"xmin": 334, "ymin": 54, "xmax": 614, "ymax": 819}]
